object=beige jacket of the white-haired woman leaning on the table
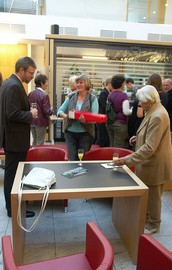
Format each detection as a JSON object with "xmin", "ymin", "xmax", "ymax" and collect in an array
[{"xmin": 125, "ymin": 102, "xmax": 172, "ymax": 185}]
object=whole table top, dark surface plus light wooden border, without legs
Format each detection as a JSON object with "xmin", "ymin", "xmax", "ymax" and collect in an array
[{"xmin": 12, "ymin": 161, "xmax": 147, "ymax": 198}]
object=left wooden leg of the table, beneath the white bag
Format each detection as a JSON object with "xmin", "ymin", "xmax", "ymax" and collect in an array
[{"xmin": 11, "ymin": 195, "xmax": 26, "ymax": 265}]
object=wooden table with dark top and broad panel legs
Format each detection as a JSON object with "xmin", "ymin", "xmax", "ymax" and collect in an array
[{"xmin": 11, "ymin": 161, "xmax": 148, "ymax": 265}]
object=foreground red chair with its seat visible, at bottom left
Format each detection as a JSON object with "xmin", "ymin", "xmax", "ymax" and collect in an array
[{"xmin": 2, "ymin": 222, "xmax": 114, "ymax": 270}]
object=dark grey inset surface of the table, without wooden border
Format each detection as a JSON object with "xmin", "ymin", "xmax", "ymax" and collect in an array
[{"xmin": 23, "ymin": 163, "xmax": 138, "ymax": 189}]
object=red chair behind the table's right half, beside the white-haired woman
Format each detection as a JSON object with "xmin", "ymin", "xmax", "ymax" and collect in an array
[{"xmin": 84, "ymin": 147, "xmax": 135, "ymax": 172}]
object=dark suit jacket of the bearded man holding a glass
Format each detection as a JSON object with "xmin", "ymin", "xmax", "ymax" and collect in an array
[{"xmin": 0, "ymin": 74, "xmax": 32, "ymax": 152}]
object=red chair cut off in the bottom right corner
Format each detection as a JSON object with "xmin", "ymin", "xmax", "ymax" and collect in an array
[{"xmin": 136, "ymin": 234, "xmax": 172, "ymax": 270}]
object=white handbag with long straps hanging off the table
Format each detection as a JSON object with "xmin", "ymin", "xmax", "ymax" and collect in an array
[{"xmin": 17, "ymin": 167, "xmax": 56, "ymax": 232}]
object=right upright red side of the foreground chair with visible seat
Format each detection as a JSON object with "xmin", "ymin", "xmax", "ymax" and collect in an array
[{"xmin": 86, "ymin": 222, "xmax": 114, "ymax": 270}]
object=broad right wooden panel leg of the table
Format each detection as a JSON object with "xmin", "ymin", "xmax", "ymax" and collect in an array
[{"xmin": 112, "ymin": 191, "xmax": 148, "ymax": 264}]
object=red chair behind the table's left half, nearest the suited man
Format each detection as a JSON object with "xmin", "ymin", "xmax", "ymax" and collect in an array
[{"xmin": 26, "ymin": 145, "xmax": 68, "ymax": 213}]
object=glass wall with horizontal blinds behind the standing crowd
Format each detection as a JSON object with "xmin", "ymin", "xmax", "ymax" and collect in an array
[{"xmin": 50, "ymin": 36, "xmax": 172, "ymax": 140}]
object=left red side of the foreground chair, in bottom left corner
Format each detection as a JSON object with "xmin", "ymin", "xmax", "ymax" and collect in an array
[{"xmin": 1, "ymin": 236, "xmax": 18, "ymax": 270}]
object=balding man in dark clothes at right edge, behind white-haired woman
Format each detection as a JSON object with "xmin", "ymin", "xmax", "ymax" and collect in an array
[{"xmin": 163, "ymin": 78, "xmax": 172, "ymax": 134}]
